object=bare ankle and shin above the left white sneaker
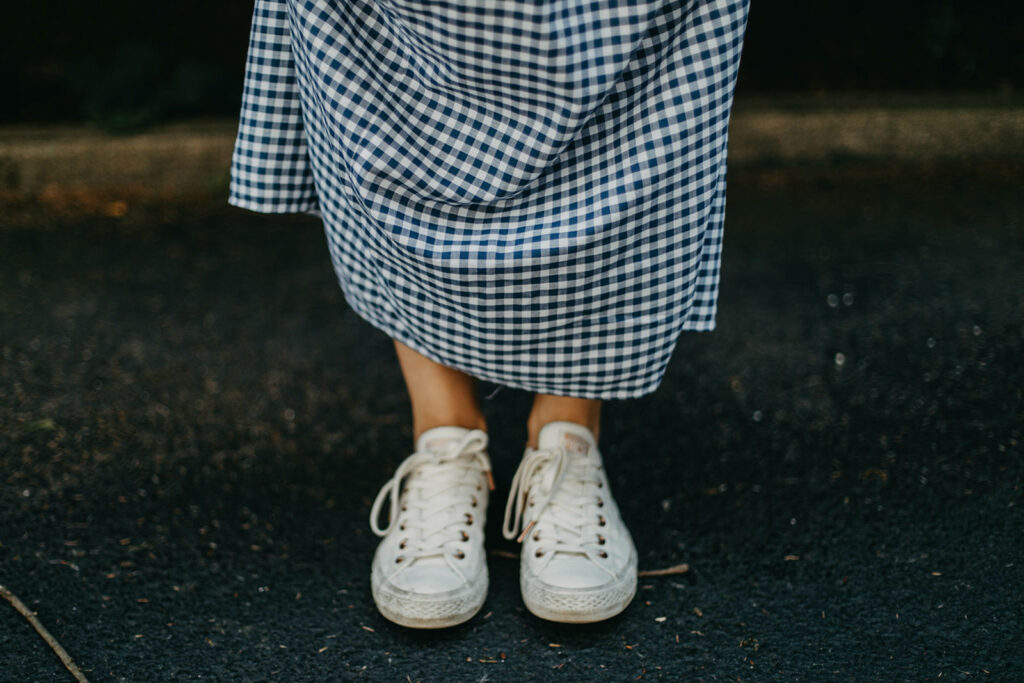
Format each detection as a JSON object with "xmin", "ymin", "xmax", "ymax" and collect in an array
[{"xmin": 394, "ymin": 341, "xmax": 487, "ymax": 439}]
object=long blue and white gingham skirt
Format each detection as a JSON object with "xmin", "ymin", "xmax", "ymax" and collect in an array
[{"xmin": 229, "ymin": 0, "xmax": 748, "ymax": 398}]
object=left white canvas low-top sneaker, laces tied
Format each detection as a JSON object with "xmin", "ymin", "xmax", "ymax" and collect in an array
[{"xmin": 370, "ymin": 427, "xmax": 494, "ymax": 629}]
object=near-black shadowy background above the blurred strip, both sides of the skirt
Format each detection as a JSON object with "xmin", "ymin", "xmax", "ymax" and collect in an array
[{"xmin": 6, "ymin": 0, "xmax": 1024, "ymax": 130}]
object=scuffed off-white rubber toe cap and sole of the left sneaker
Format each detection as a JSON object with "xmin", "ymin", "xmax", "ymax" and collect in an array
[{"xmin": 370, "ymin": 572, "xmax": 487, "ymax": 629}]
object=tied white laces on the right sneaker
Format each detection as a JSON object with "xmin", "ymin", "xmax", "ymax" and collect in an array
[{"xmin": 502, "ymin": 449, "xmax": 614, "ymax": 577}]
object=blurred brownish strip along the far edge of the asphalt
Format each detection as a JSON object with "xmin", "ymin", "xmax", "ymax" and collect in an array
[{"xmin": 0, "ymin": 93, "xmax": 1024, "ymax": 224}]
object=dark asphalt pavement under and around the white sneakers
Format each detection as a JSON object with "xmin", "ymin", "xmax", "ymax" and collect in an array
[{"xmin": 0, "ymin": 163, "xmax": 1024, "ymax": 682}]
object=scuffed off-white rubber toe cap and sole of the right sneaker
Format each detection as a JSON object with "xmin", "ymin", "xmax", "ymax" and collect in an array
[{"xmin": 519, "ymin": 552, "xmax": 637, "ymax": 624}]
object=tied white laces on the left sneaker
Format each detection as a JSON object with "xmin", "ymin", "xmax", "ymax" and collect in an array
[{"xmin": 370, "ymin": 429, "xmax": 494, "ymax": 574}]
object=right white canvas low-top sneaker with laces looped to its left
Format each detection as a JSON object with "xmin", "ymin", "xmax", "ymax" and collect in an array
[{"xmin": 502, "ymin": 422, "xmax": 637, "ymax": 624}]
